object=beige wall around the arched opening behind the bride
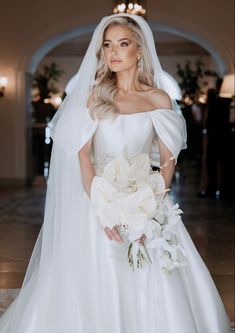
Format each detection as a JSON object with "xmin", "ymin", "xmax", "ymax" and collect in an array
[{"xmin": 0, "ymin": 0, "xmax": 234, "ymax": 182}]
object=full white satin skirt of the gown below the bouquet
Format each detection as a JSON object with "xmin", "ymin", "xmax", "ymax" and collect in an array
[{"xmin": 0, "ymin": 194, "xmax": 231, "ymax": 333}]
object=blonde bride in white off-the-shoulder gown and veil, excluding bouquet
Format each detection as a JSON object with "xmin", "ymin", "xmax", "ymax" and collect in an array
[{"xmin": 0, "ymin": 14, "xmax": 231, "ymax": 333}]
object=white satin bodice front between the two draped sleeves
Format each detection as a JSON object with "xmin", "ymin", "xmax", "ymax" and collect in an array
[{"xmin": 92, "ymin": 112, "xmax": 154, "ymax": 171}]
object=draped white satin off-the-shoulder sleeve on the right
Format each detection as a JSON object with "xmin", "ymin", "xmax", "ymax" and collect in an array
[{"xmin": 150, "ymin": 109, "xmax": 187, "ymax": 166}]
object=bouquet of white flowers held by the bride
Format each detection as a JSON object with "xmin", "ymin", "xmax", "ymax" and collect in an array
[{"xmin": 91, "ymin": 154, "xmax": 186, "ymax": 272}]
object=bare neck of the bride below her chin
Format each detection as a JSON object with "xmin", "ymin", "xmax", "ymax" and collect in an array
[{"xmin": 116, "ymin": 68, "xmax": 140, "ymax": 94}]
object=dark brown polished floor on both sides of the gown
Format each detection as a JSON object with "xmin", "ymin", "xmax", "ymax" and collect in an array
[{"xmin": 0, "ymin": 163, "xmax": 235, "ymax": 322}]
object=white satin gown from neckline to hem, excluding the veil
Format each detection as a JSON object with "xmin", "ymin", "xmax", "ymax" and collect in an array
[{"xmin": 0, "ymin": 110, "xmax": 231, "ymax": 333}]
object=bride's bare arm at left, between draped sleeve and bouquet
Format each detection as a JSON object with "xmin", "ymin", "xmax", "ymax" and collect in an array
[{"xmin": 78, "ymin": 139, "xmax": 95, "ymax": 196}]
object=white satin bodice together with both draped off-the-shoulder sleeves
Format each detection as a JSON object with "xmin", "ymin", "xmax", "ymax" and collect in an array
[{"xmin": 51, "ymin": 108, "xmax": 187, "ymax": 171}]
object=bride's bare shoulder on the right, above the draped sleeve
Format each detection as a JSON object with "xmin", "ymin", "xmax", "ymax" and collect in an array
[{"xmin": 148, "ymin": 88, "xmax": 172, "ymax": 110}]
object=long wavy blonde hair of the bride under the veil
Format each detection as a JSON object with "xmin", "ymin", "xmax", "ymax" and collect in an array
[{"xmin": 89, "ymin": 16, "xmax": 154, "ymax": 119}]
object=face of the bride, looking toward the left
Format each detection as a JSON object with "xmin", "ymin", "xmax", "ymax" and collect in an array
[{"xmin": 103, "ymin": 25, "xmax": 140, "ymax": 72}]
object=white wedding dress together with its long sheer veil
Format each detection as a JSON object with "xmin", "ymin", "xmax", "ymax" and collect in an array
[{"xmin": 0, "ymin": 14, "xmax": 231, "ymax": 333}]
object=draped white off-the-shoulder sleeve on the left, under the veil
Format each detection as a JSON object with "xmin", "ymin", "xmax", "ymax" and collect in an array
[{"xmin": 52, "ymin": 108, "xmax": 98, "ymax": 156}]
